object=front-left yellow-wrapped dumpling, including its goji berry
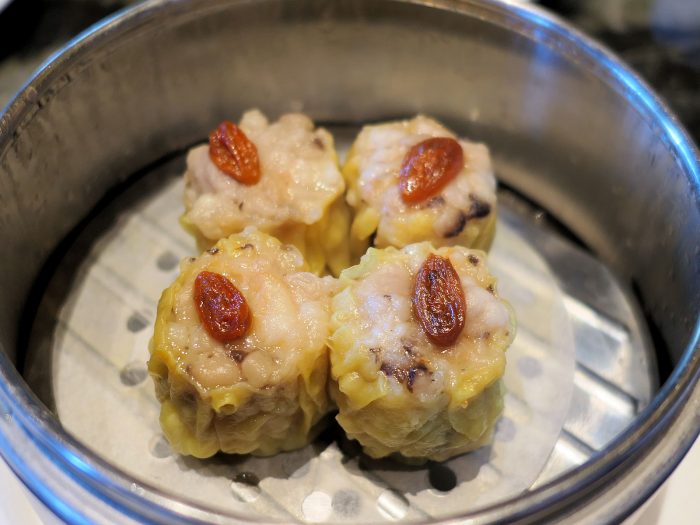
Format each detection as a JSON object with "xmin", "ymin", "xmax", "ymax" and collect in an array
[{"xmin": 148, "ymin": 229, "xmax": 337, "ymax": 457}]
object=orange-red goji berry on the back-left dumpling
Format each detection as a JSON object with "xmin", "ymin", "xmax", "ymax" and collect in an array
[{"xmin": 209, "ymin": 120, "xmax": 260, "ymax": 186}]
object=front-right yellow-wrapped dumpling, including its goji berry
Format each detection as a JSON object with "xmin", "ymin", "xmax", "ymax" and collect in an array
[{"xmin": 329, "ymin": 243, "xmax": 514, "ymax": 461}]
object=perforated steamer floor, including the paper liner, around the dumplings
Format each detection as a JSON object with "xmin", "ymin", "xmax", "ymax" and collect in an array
[{"xmin": 24, "ymin": 129, "xmax": 657, "ymax": 522}]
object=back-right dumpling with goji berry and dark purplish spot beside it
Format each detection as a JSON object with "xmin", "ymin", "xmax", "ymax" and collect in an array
[{"xmin": 343, "ymin": 115, "xmax": 496, "ymax": 256}]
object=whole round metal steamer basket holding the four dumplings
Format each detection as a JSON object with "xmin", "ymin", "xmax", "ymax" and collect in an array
[{"xmin": 0, "ymin": 0, "xmax": 700, "ymax": 523}]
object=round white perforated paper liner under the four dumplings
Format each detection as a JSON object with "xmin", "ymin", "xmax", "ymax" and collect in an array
[{"xmin": 27, "ymin": 172, "xmax": 574, "ymax": 523}]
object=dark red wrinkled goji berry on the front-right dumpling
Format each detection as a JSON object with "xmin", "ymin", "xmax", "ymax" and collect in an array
[{"xmin": 413, "ymin": 254, "xmax": 466, "ymax": 346}]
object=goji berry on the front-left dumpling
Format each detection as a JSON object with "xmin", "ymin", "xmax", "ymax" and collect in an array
[{"xmin": 194, "ymin": 271, "xmax": 251, "ymax": 343}]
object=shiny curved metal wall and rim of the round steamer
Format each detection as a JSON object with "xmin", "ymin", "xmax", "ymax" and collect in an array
[{"xmin": 0, "ymin": 0, "xmax": 700, "ymax": 523}]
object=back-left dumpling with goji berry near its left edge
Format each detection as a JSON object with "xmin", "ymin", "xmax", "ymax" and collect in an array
[{"xmin": 182, "ymin": 110, "xmax": 349, "ymax": 273}]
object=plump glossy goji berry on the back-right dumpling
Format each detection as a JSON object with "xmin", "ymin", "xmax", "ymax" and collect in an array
[{"xmin": 399, "ymin": 137, "xmax": 464, "ymax": 204}]
